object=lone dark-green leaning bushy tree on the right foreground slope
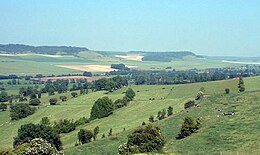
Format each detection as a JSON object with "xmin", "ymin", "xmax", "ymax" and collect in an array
[{"xmin": 177, "ymin": 117, "xmax": 200, "ymax": 139}]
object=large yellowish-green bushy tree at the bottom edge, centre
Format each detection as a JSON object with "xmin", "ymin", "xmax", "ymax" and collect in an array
[{"xmin": 118, "ymin": 124, "xmax": 165, "ymax": 154}]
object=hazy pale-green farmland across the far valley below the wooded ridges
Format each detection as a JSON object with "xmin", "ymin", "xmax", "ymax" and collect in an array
[{"xmin": 0, "ymin": 51, "xmax": 239, "ymax": 75}]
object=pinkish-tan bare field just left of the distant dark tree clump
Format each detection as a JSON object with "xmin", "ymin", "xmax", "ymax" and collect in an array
[{"xmin": 56, "ymin": 65, "xmax": 116, "ymax": 72}]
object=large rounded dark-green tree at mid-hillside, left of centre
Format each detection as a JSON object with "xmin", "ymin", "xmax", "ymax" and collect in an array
[{"xmin": 90, "ymin": 97, "xmax": 113, "ymax": 120}]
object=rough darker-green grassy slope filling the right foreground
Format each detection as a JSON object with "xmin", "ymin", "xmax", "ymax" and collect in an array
[{"xmin": 65, "ymin": 77, "xmax": 260, "ymax": 155}]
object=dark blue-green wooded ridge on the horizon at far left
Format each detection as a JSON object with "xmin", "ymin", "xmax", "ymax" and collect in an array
[{"xmin": 0, "ymin": 44, "xmax": 88, "ymax": 54}]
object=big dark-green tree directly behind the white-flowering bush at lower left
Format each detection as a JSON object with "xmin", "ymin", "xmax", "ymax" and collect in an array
[{"xmin": 13, "ymin": 123, "xmax": 62, "ymax": 150}]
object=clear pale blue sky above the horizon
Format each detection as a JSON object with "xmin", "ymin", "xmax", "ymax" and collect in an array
[{"xmin": 0, "ymin": 0, "xmax": 260, "ymax": 56}]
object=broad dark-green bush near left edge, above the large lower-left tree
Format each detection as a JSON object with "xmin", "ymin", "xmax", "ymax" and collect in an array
[{"xmin": 10, "ymin": 103, "xmax": 36, "ymax": 120}]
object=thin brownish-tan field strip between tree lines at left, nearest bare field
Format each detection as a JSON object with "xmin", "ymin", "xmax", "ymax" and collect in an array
[{"xmin": 32, "ymin": 76, "xmax": 101, "ymax": 82}]
